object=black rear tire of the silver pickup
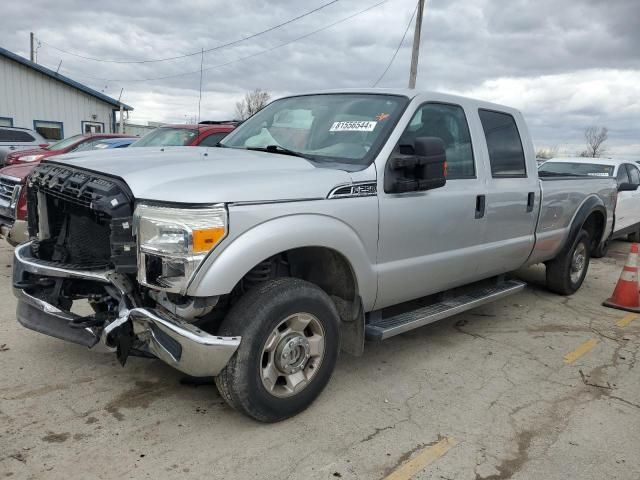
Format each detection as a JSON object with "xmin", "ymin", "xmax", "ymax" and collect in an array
[{"xmin": 547, "ymin": 230, "xmax": 591, "ymax": 295}]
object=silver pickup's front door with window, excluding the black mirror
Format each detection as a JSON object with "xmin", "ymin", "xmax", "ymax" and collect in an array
[{"xmin": 375, "ymin": 102, "xmax": 486, "ymax": 309}]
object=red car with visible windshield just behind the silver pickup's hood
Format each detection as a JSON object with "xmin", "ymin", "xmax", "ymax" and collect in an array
[{"xmin": 131, "ymin": 120, "xmax": 238, "ymax": 147}]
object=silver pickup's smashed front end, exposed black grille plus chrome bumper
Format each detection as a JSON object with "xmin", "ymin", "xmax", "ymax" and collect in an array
[{"xmin": 13, "ymin": 164, "xmax": 240, "ymax": 377}]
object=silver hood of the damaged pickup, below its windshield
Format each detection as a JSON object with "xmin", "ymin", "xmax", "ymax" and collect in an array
[{"xmin": 51, "ymin": 147, "xmax": 351, "ymax": 203}]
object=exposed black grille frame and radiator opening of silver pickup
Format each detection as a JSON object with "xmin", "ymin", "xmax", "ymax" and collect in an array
[{"xmin": 28, "ymin": 163, "xmax": 137, "ymax": 273}]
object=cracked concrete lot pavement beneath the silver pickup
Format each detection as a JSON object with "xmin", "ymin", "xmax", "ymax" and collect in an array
[{"xmin": 0, "ymin": 242, "xmax": 640, "ymax": 480}]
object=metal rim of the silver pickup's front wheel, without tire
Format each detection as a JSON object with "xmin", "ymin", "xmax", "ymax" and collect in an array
[{"xmin": 260, "ymin": 313, "xmax": 325, "ymax": 398}]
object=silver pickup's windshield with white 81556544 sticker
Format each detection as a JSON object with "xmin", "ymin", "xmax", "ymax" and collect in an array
[{"xmin": 220, "ymin": 94, "xmax": 409, "ymax": 165}]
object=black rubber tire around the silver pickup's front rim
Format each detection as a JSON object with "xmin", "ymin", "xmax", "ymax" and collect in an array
[{"xmin": 216, "ymin": 278, "xmax": 340, "ymax": 422}]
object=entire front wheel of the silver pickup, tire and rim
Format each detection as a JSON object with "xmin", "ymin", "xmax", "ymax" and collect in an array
[{"xmin": 216, "ymin": 278, "xmax": 340, "ymax": 422}]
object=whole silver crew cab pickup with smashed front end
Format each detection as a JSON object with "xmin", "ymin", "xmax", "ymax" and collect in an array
[{"xmin": 13, "ymin": 89, "xmax": 616, "ymax": 422}]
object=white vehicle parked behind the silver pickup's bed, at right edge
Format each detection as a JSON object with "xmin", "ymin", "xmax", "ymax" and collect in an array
[{"xmin": 538, "ymin": 157, "xmax": 640, "ymax": 246}]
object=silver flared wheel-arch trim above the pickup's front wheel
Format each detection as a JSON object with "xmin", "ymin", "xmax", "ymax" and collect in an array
[{"xmin": 187, "ymin": 214, "xmax": 378, "ymax": 310}]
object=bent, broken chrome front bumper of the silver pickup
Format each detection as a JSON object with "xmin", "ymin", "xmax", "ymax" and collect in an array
[{"xmin": 13, "ymin": 242, "xmax": 240, "ymax": 377}]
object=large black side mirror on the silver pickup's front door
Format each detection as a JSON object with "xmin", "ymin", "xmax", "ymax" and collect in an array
[{"xmin": 384, "ymin": 137, "xmax": 447, "ymax": 193}]
